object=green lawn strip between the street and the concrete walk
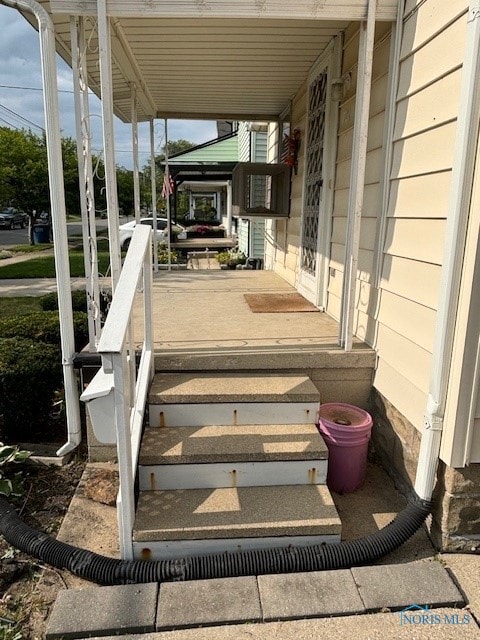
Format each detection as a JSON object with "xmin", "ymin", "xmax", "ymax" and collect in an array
[{"xmin": 0, "ymin": 251, "xmax": 110, "ymax": 280}]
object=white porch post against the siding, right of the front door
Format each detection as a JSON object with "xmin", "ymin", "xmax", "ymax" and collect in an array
[{"xmin": 339, "ymin": 0, "xmax": 376, "ymax": 351}]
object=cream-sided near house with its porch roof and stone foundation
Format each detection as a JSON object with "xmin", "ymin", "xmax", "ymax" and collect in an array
[{"xmin": 16, "ymin": 0, "xmax": 480, "ymax": 551}]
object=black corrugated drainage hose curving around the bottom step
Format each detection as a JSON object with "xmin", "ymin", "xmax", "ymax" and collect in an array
[{"xmin": 0, "ymin": 496, "xmax": 432, "ymax": 585}]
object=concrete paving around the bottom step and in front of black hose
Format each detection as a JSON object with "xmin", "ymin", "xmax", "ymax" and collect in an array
[{"xmin": 41, "ymin": 463, "xmax": 480, "ymax": 640}]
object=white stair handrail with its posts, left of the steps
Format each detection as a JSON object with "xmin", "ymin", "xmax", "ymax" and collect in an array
[{"xmin": 98, "ymin": 225, "xmax": 154, "ymax": 559}]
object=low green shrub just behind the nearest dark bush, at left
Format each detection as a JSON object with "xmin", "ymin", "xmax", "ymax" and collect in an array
[{"xmin": 0, "ymin": 311, "xmax": 88, "ymax": 351}]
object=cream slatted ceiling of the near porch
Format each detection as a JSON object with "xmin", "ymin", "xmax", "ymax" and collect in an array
[{"xmin": 19, "ymin": 0, "xmax": 395, "ymax": 122}]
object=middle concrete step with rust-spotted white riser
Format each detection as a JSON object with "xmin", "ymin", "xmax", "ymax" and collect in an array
[{"xmin": 139, "ymin": 424, "xmax": 328, "ymax": 491}]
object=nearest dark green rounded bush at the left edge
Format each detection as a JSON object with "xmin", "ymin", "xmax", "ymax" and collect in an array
[{"xmin": 0, "ymin": 338, "xmax": 62, "ymax": 442}]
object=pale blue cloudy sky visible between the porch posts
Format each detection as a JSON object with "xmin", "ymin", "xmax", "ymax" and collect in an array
[{"xmin": 0, "ymin": 5, "xmax": 217, "ymax": 169}]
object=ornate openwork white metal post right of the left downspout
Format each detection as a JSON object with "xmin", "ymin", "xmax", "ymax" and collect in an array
[{"xmin": 70, "ymin": 17, "xmax": 101, "ymax": 351}]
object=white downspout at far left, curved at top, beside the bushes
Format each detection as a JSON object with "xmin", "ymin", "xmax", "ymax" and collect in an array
[{"xmin": 2, "ymin": 0, "xmax": 81, "ymax": 456}]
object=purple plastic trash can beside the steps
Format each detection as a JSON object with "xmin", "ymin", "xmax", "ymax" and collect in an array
[{"xmin": 318, "ymin": 402, "xmax": 373, "ymax": 493}]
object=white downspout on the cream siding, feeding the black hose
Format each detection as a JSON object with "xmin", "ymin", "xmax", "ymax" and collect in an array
[{"xmin": 415, "ymin": 0, "xmax": 480, "ymax": 500}]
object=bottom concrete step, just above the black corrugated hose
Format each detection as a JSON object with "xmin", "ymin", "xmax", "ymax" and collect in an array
[{"xmin": 133, "ymin": 485, "xmax": 341, "ymax": 559}]
